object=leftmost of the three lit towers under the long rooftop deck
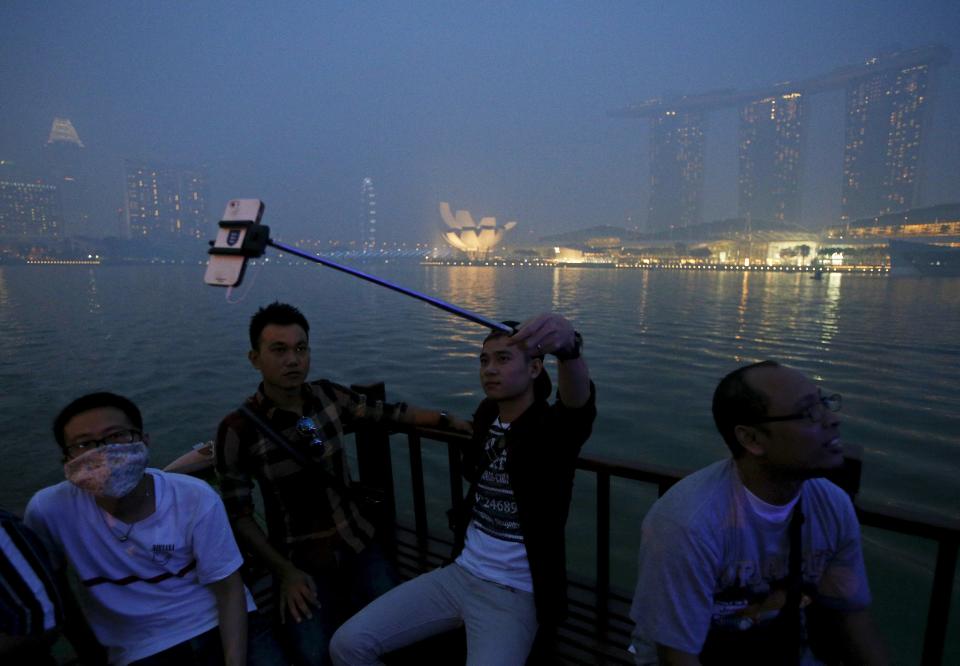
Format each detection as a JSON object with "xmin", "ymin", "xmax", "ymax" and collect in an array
[{"xmin": 647, "ymin": 110, "xmax": 704, "ymax": 231}]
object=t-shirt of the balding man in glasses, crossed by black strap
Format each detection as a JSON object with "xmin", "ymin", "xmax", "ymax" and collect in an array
[{"xmin": 630, "ymin": 459, "xmax": 870, "ymax": 664}]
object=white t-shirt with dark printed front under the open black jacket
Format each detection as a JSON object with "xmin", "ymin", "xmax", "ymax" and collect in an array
[{"xmin": 457, "ymin": 417, "xmax": 533, "ymax": 592}]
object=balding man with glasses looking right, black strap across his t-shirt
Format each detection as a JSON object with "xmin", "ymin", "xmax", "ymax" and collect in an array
[{"xmin": 630, "ymin": 361, "xmax": 886, "ymax": 665}]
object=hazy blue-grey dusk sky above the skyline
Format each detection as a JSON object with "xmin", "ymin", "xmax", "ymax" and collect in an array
[{"xmin": 0, "ymin": 0, "xmax": 960, "ymax": 241}]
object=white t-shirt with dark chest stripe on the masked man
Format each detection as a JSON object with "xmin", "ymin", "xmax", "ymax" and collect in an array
[{"xmin": 24, "ymin": 469, "xmax": 256, "ymax": 665}]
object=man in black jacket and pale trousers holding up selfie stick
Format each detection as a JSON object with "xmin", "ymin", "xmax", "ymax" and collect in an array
[{"xmin": 330, "ymin": 313, "xmax": 597, "ymax": 666}]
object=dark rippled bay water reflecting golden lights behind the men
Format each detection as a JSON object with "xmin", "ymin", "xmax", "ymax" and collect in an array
[{"xmin": 0, "ymin": 264, "xmax": 960, "ymax": 663}]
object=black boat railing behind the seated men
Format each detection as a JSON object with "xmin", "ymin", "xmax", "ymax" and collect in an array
[{"xmin": 368, "ymin": 418, "xmax": 960, "ymax": 664}]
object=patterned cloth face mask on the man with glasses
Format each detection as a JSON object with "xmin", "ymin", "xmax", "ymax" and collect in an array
[{"xmin": 63, "ymin": 442, "xmax": 149, "ymax": 498}]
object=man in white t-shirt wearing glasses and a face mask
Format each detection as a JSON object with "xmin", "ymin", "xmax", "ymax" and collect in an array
[{"xmin": 25, "ymin": 393, "xmax": 282, "ymax": 666}]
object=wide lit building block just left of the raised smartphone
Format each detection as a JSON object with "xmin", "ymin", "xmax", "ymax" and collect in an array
[{"xmin": 125, "ymin": 160, "xmax": 209, "ymax": 239}]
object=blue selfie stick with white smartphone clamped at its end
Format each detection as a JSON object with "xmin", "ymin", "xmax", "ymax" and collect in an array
[{"xmin": 204, "ymin": 199, "xmax": 514, "ymax": 334}]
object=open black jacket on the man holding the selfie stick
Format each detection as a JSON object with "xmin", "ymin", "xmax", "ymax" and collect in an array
[{"xmin": 454, "ymin": 382, "xmax": 597, "ymax": 625}]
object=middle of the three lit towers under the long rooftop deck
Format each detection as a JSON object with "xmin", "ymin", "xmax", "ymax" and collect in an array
[{"xmin": 739, "ymin": 92, "xmax": 803, "ymax": 223}]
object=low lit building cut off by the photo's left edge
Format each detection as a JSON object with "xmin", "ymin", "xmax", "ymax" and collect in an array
[{"xmin": 0, "ymin": 180, "xmax": 62, "ymax": 241}]
